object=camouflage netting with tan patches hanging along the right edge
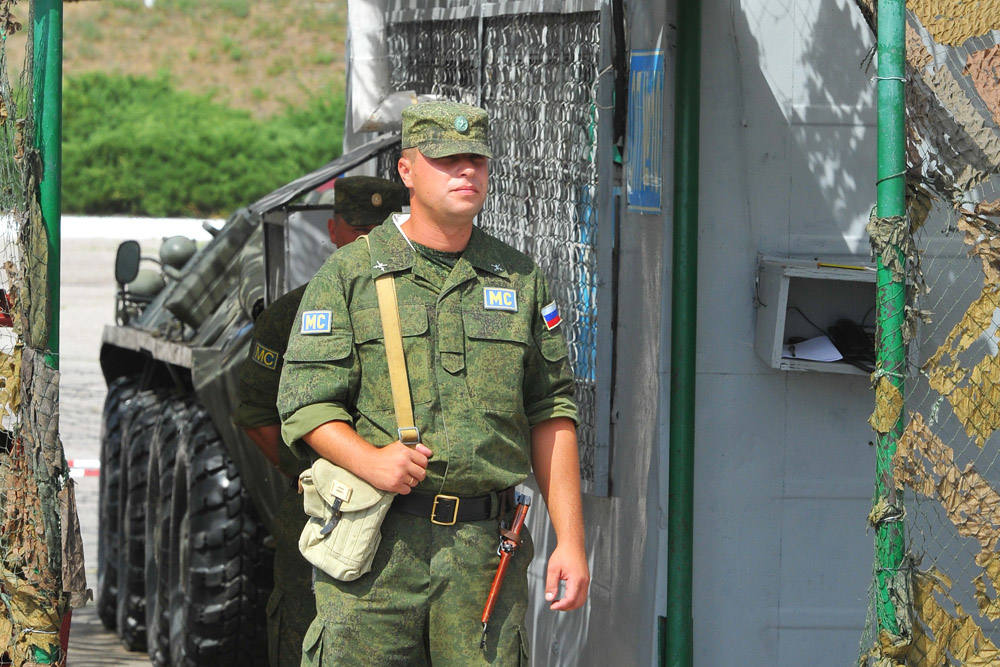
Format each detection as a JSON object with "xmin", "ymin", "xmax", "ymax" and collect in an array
[{"xmin": 857, "ymin": 0, "xmax": 1000, "ymax": 667}]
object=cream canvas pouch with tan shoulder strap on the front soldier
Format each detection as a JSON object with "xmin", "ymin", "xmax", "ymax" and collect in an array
[{"xmin": 299, "ymin": 235, "xmax": 420, "ymax": 581}]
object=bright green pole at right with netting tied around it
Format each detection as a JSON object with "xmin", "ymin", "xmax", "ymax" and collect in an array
[{"xmin": 875, "ymin": 0, "xmax": 906, "ymax": 635}]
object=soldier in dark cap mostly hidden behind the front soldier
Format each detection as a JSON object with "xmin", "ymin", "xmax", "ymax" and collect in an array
[{"xmin": 233, "ymin": 176, "xmax": 408, "ymax": 667}]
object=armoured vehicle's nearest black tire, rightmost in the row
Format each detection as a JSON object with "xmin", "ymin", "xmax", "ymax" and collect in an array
[{"xmin": 169, "ymin": 406, "xmax": 271, "ymax": 666}]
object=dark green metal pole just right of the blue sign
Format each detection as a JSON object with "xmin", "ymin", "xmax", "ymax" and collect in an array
[{"xmin": 660, "ymin": 0, "xmax": 701, "ymax": 667}]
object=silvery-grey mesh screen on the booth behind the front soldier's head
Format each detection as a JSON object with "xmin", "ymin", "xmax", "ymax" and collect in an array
[{"xmin": 383, "ymin": 3, "xmax": 606, "ymax": 484}]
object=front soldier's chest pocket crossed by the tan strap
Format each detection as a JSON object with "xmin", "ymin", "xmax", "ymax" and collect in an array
[{"xmin": 351, "ymin": 304, "xmax": 433, "ymax": 412}]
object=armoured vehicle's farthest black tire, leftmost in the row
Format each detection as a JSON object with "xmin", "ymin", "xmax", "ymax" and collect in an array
[{"xmin": 97, "ymin": 376, "xmax": 139, "ymax": 632}]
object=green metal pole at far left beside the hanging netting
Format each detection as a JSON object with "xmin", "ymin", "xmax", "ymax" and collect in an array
[{"xmin": 32, "ymin": 0, "xmax": 63, "ymax": 369}]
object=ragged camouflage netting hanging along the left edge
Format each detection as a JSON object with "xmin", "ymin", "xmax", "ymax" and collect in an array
[{"xmin": 0, "ymin": 0, "xmax": 87, "ymax": 666}]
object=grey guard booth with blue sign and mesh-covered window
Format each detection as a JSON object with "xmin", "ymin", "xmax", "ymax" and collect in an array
[{"xmin": 286, "ymin": 0, "xmax": 888, "ymax": 666}]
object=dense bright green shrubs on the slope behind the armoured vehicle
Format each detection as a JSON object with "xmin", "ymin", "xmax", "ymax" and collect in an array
[{"xmin": 63, "ymin": 73, "xmax": 344, "ymax": 216}]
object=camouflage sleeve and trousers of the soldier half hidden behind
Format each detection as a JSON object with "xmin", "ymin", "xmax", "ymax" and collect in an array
[{"xmin": 233, "ymin": 285, "xmax": 316, "ymax": 667}]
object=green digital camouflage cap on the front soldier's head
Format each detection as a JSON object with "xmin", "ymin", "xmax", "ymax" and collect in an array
[{"xmin": 403, "ymin": 102, "xmax": 493, "ymax": 158}]
